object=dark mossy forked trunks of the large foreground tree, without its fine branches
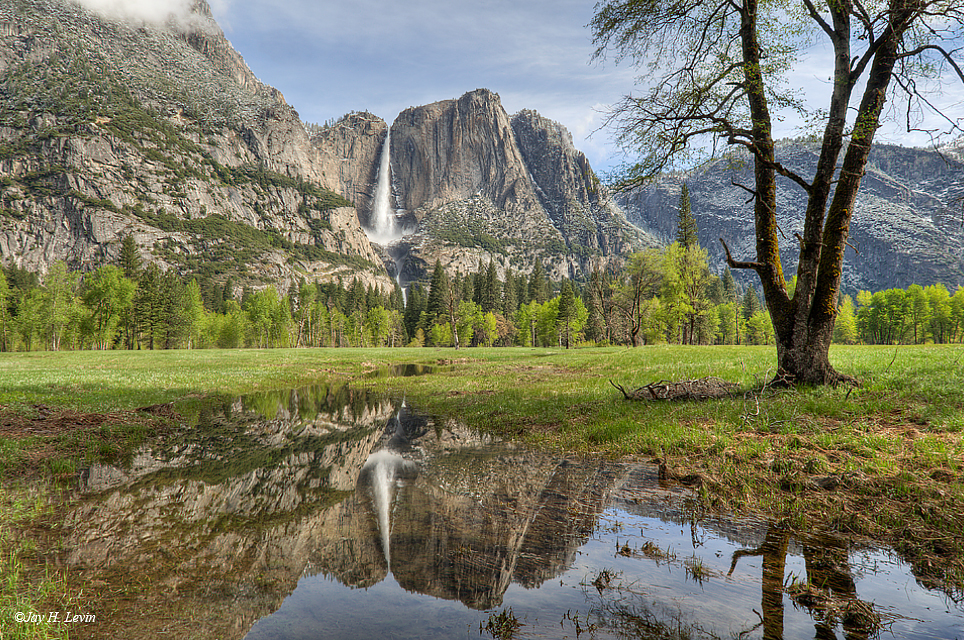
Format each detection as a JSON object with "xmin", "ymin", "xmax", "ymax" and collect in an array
[{"xmin": 724, "ymin": 0, "xmax": 920, "ymax": 385}]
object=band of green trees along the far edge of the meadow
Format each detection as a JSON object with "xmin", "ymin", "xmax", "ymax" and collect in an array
[{"xmin": 0, "ymin": 231, "xmax": 964, "ymax": 351}]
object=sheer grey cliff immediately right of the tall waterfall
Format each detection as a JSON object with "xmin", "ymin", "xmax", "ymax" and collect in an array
[{"xmin": 391, "ymin": 89, "xmax": 653, "ymax": 278}]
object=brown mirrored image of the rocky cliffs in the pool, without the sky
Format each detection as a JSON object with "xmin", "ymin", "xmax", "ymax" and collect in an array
[{"xmin": 67, "ymin": 388, "xmax": 668, "ymax": 637}]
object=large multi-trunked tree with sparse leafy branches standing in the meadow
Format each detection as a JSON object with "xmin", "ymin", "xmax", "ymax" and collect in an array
[{"xmin": 592, "ymin": 0, "xmax": 964, "ymax": 384}]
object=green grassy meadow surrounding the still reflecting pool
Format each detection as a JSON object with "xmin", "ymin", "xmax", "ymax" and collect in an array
[{"xmin": 0, "ymin": 345, "xmax": 964, "ymax": 632}]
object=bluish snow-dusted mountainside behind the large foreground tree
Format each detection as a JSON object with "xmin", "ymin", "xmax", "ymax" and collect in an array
[{"xmin": 617, "ymin": 142, "xmax": 964, "ymax": 294}]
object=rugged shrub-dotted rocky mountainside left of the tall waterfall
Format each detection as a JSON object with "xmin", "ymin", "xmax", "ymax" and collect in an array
[{"xmin": 0, "ymin": 0, "xmax": 392, "ymax": 287}]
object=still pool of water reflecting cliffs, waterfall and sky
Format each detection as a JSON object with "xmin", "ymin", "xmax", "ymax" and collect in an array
[{"xmin": 65, "ymin": 387, "xmax": 964, "ymax": 640}]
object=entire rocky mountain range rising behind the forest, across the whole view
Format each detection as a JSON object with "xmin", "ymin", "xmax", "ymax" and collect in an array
[{"xmin": 0, "ymin": 0, "xmax": 964, "ymax": 296}]
